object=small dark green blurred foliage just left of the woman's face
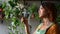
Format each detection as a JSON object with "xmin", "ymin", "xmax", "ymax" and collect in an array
[{"xmin": 28, "ymin": 3, "xmax": 39, "ymax": 20}]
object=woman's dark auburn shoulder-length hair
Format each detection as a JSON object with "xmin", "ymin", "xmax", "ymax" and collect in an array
[{"xmin": 41, "ymin": 2, "xmax": 57, "ymax": 22}]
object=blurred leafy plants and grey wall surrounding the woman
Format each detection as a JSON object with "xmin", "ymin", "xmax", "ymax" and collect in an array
[{"xmin": 0, "ymin": 0, "xmax": 60, "ymax": 34}]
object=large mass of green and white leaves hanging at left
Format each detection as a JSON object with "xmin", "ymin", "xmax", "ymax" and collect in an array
[{"xmin": 2, "ymin": 0, "xmax": 24, "ymax": 34}]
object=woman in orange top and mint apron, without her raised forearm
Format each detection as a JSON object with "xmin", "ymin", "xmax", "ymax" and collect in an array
[{"xmin": 34, "ymin": 2, "xmax": 60, "ymax": 34}]
